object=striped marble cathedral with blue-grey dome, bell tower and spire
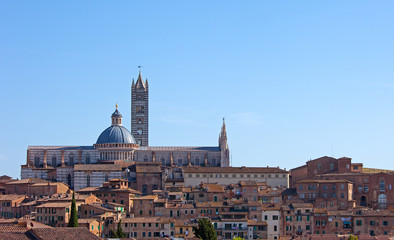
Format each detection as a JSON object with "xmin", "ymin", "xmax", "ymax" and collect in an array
[{"xmin": 21, "ymin": 72, "xmax": 229, "ymax": 190}]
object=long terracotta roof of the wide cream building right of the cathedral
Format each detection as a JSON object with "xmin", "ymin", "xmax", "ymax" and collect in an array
[{"xmin": 182, "ymin": 166, "xmax": 289, "ymax": 174}]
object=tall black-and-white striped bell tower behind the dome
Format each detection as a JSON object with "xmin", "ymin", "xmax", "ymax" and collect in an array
[{"xmin": 131, "ymin": 71, "xmax": 149, "ymax": 146}]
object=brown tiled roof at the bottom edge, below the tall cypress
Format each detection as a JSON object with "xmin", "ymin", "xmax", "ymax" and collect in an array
[{"xmin": 29, "ymin": 227, "xmax": 102, "ymax": 240}]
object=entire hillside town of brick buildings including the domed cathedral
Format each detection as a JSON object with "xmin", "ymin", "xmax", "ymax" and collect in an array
[{"xmin": 0, "ymin": 73, "xmax": 394, "ymax": 239}]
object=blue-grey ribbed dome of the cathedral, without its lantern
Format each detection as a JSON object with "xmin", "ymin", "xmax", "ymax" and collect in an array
[{"xmin": 96, "ymin": 125, "xmax": 136, "ymax": 144}]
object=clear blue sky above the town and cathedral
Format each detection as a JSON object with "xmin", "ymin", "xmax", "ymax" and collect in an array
[{"xmin": 0, "ymin": 0, "xmax": 394, "ymax": 177}]
